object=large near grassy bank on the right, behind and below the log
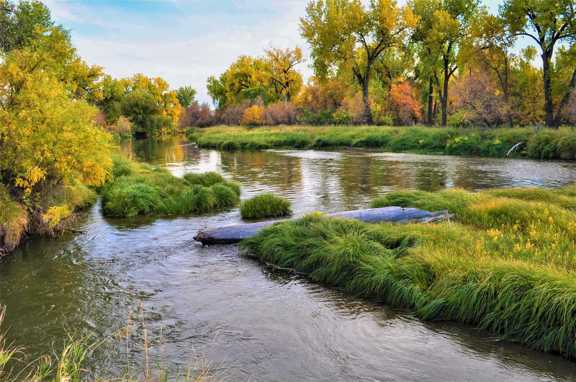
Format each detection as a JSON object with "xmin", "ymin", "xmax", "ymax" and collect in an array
[{"xmin": 243, "ymin": 186, "xmax": 576, "ymax": 359}]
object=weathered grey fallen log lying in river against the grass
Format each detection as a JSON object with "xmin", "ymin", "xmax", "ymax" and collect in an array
[{"xmin": 194, "ymin": 207, "xmax": 451, "ymax": 245}]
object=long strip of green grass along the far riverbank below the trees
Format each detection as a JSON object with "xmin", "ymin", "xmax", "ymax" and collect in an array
[{"xmin": 189, "ymin": 126, "xmax": 576, "ymax": 160}]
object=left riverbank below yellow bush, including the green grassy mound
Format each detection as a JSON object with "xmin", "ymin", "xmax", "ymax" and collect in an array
[{"xmin": 0, "ymin": 155, "xmax": 240, "ymax": 257}]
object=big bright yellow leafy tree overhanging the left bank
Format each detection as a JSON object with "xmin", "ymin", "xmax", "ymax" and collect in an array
[{"xmin": 0, "ymin": 35, "xmax": 112, "ymax": 202}]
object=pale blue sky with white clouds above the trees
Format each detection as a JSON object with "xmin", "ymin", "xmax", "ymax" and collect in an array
[{"xmin": 43, "ymin": 0, "xmax": 500, "ymax": 103}]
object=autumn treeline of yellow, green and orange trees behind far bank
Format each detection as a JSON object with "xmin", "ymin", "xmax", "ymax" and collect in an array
[{"xmin": 190, "ymin": 0, "xmax": 576, "ymax": 127}]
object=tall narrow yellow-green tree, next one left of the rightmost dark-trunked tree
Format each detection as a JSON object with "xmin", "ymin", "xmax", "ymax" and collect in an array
[{"xmin": 412, "ymin": 0, "xmax": 478, "ymax": 126}]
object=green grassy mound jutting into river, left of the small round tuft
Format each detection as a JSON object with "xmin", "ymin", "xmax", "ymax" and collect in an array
[{"xmin": 101, "ymin": 158, "xmax": 240, "ymax": 218}]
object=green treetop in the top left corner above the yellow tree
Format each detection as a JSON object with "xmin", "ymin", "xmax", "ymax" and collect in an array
[{"xmin": 0, "ymin": 0, "xmax": 54, "ymax": 53}]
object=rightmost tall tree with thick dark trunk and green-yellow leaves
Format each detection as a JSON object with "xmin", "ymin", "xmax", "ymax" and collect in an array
[{"xmin": 501, "ymin": 0, "xmax": 576, "ymax": 127}]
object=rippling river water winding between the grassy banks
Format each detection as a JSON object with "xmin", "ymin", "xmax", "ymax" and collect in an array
[{"xmin": 0, "ymin": 140, "xmax": 576, "ymax": 382}]
